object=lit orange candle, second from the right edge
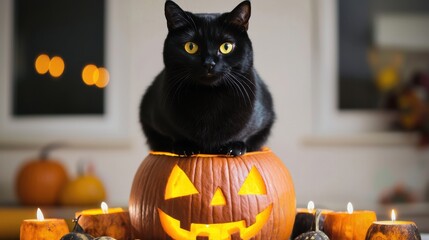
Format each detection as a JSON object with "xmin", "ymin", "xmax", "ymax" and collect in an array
[{"xmin": 323, "ymin": 202, "xmax": 377, "ymax": 240}]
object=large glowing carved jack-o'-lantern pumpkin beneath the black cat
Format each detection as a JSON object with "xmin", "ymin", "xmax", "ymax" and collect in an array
[{"xmin": 129, "ymin": 149, "xmax": 296, "ymax": 240}]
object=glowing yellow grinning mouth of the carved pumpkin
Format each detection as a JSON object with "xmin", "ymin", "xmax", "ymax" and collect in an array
[{"xmin": 158, "ymin": 204, "xmax": 273, "ymax": 240}]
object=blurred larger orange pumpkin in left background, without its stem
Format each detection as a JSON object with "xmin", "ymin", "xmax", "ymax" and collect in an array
[{"xmin": 16, "ymin": 159, "xmax": 68, "ymax": 205}]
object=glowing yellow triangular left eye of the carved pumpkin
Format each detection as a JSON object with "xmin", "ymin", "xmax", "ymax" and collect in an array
[{"xmin": 164, "ymin": 165, "xmax": 199, "ymax": 200}]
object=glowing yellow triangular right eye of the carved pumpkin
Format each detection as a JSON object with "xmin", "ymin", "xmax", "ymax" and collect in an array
[{"xmin": 238, "ymin": 166, "xmax": 267, "ymax": 195}]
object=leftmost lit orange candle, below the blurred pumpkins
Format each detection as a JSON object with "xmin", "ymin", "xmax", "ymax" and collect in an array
[{"xmin": 19, "ymin": 208, "xmax": 69, "ymax": 240}]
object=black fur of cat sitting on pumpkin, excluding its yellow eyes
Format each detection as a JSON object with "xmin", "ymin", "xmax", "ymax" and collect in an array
[{"xmin": 140, "ymin": 1, "xmax": 274, "ymax": 156}]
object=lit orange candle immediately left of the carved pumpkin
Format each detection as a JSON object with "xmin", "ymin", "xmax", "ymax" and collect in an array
[{"xmin": 76, "ymin": 202, "xmax": 132, "ymax": 239}]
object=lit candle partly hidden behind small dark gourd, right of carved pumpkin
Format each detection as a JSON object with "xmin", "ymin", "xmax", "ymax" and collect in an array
[{"xmin": 291, "ymin": 201, "xmax": 332, "ymax": 239}]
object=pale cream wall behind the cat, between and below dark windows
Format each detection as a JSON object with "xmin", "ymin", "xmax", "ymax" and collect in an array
[{"xmin": 0, "ymin": 0, "xmax": 429, "ymax": 208}]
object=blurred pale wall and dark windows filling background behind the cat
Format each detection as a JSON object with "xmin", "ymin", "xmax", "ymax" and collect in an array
[{"xmin": 0, "ymin": 0, "xmax": 429, "ymax": 236}]
